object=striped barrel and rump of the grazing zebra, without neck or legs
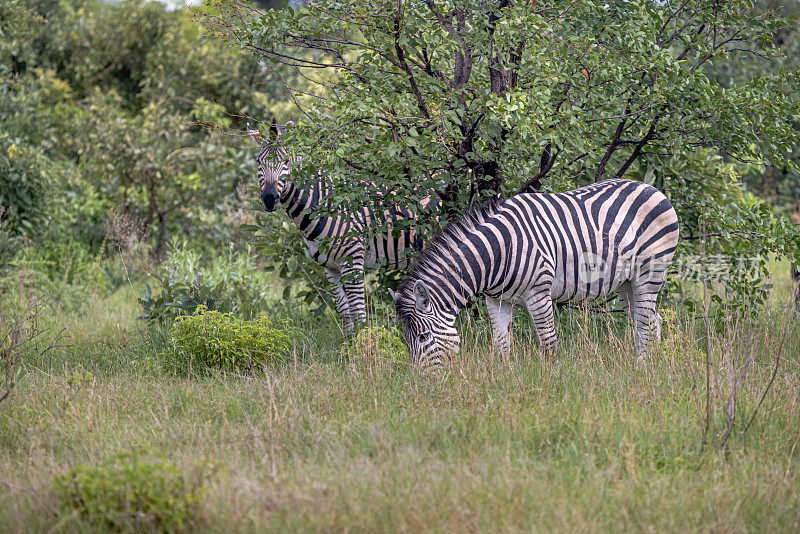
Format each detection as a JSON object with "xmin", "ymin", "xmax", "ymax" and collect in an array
[{"xmin": 504, "ymin": 180, "xmax": 678, "ymax": 302}]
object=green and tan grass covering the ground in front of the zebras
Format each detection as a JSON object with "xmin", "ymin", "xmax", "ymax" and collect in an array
[{"xmin": 0, "ymin": 274, "xmax": 800, "ymax": 532}]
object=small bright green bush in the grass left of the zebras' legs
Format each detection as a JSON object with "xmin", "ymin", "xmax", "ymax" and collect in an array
[{"xmin": 170, "ymin": 306, "xmax": 292, "ymax": 371}]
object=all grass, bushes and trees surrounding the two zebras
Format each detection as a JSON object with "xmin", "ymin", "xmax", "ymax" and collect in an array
[{"xmin": 0, "ymin": 0, "xmax": 800, "ymax": 531}]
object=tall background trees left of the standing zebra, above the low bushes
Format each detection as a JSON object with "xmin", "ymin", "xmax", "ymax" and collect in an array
[{"xmin": 0, "ymin": 0, "xmax": 279, "ymax": 256}]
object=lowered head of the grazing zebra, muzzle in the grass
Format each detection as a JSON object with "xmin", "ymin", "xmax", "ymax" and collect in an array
[{"xmin": 394, "ymin": 279, "xmax": 461, "ymax": 372}]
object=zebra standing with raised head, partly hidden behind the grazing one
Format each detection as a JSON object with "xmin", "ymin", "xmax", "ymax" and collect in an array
[{"xmin": 249, "ymin": 122, "xmax": 438, "ymax": 332}]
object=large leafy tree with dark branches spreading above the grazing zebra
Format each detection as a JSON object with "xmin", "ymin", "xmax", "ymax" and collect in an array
[{"xmin": 203, "ymin": 0, "xmax": 800, "ymax": 310}]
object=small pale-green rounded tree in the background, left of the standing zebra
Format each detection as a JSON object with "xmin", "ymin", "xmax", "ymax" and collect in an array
[{"xmin": 81, "ymin": 92, "xmax": 248, "ymax": 257}]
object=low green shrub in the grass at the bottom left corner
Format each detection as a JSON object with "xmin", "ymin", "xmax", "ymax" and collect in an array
[{"xmin": 53, "ymin": 454, "xmax": 211, "ymax": 532}]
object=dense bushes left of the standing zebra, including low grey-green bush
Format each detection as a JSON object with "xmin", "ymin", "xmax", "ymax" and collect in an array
[{"xmin": 0, "ymin": 0, "xmax": 306, "ymax": 318}]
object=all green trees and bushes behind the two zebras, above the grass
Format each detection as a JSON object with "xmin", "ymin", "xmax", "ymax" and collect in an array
[{"xmin": 0, "ymin": 0, "xmax": 800, "ymax": 322}]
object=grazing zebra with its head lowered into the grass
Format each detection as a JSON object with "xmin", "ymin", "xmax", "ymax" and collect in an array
[{"xmin": 395, "ymin": 179, "xmax": 678, "ymax": 370}]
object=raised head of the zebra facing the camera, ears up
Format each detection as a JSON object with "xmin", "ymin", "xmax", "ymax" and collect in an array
[{"xmin": 248, "ymin": 120, "xmax": 294, "ymax": 211}]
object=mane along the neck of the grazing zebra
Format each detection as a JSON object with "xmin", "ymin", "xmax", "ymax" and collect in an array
[{"xmin": 395, "ymin": 199, "xmax": 504, "ymax": 323}]
